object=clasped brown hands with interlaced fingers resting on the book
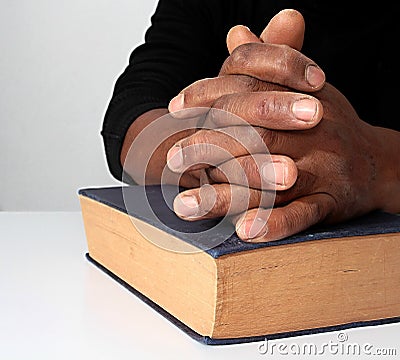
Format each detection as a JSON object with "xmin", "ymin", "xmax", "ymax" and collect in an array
[{"xmin": 167, "ymin": 10, "xmax": 386, "ymax": 242}]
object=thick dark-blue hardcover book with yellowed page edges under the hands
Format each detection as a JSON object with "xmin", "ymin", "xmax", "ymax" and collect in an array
[{"xmin": 78, "ymin": 185, "xmax": 400, "ymax": 345}]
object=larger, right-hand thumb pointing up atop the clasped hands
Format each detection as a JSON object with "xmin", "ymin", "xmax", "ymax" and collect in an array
[{"xmin": 260, "ymin": 9, "xmax": 305, "ymax": 51}]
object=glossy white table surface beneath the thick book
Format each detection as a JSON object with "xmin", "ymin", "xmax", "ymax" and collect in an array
[{"xmin": 0, "ymin": 212, "xmax": 400, "ymax": 360}]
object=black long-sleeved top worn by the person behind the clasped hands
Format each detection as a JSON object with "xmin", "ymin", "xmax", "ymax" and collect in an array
[{"xmin": 101, "ymin": 0, "xmax": 400, "ymax": 180}]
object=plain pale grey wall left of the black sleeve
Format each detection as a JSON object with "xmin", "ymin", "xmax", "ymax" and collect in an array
[{"xmin": 0, "ymin": 0, "xmax": 157, "ymax": 211}]
